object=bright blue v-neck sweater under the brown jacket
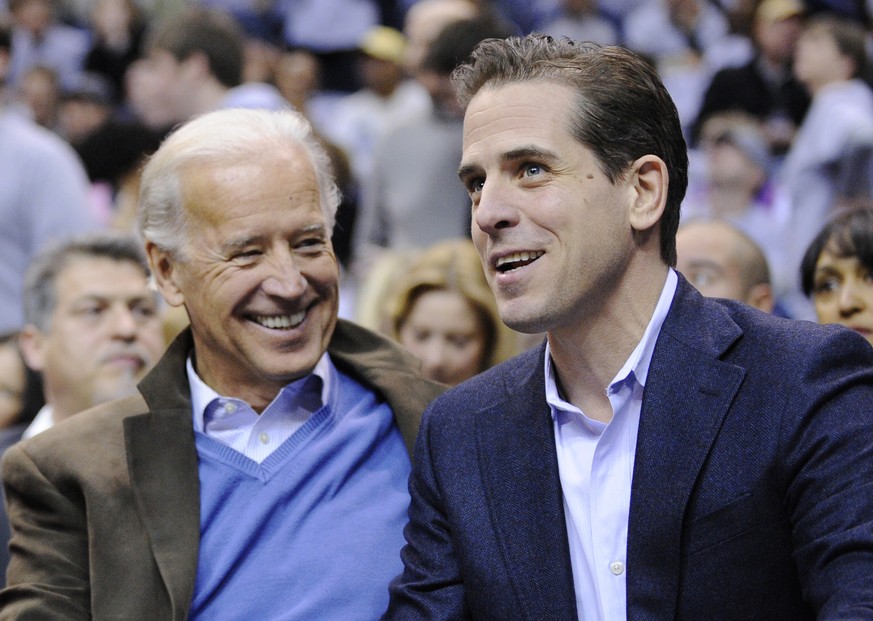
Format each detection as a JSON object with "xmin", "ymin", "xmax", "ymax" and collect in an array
[{"xmin": 191, "ymin": 366, "xmax": 410, "ymax": 621}]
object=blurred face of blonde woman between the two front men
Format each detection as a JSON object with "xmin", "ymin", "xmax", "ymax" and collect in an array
[{"xmin": 399, "ymin": 289, "xmax": 485, "ymax": 385}]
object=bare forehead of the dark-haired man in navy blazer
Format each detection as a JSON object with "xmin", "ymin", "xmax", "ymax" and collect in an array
[{"xmin": 464, "ymin": 81, "xmax": 578, "ymax": 157}]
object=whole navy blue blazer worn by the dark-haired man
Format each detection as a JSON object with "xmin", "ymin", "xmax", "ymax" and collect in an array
[{"xmin": 385, "ymin": 278, "xmax": 873, "ymax": 621}]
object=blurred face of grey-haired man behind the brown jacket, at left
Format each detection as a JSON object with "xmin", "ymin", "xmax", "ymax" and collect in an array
[{"xmin": 28, "ymin": 257, "xmax": 164, "ymax": 414}]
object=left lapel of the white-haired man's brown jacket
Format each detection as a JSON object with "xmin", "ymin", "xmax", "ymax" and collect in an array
[{"xmin": 124, "ymin": 331, "xmax": 200, "ymax": 619}]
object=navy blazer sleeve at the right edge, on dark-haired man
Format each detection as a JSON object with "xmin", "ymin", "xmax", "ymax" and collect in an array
[{"xmin": 781, "ymin": 330, "xmax": 873, "ymax": 619}]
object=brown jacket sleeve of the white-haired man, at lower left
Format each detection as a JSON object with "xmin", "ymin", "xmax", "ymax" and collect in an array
[{"xmin": 0, "ymin": 443, "xmax": 91, "ymax": 621}]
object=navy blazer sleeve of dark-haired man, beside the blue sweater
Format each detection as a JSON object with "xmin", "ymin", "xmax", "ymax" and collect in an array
[{"xmin": 383, "ymin": 407, "xmax": 470, "ymax": 621}]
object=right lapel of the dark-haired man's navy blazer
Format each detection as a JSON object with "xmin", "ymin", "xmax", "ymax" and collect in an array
[{"xmin": 627, "ymin": 279, "xmax": 745, "ymax": 619}]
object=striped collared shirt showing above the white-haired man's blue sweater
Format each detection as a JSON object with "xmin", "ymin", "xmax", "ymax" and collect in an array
[{"xmin": 186, "ymin": 353, "xmax": 337, "ymax": 463}]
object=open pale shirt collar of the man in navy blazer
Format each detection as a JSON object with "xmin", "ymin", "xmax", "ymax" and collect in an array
[{"xmin": 545, "ymin": 269, "xmax": 679, "ymax": 411}]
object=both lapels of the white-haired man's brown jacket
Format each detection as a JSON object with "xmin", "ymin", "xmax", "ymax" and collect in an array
[{"xmin": 118, "ymin": 320, "xmax": 445, "ymax": 619}]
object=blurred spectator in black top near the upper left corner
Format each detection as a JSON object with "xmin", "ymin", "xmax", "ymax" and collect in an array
[{"xmin": 85, "ymin": 0, "xmax": 145, "ymax": 105}]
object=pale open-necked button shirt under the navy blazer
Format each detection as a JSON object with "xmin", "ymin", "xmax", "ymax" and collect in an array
[{"xmin": 545, "ymin": 270, "xmax": 678, "ymax": 621}]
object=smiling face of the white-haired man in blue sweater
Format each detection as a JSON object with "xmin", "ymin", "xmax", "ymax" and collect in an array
[{"xmin": 152, "ymin": 150, "xmax": 339, "ymax": 408}]
